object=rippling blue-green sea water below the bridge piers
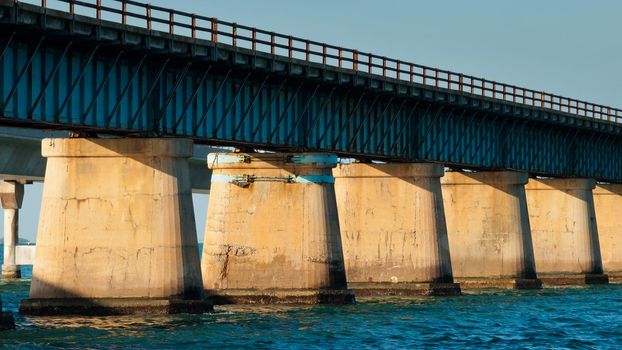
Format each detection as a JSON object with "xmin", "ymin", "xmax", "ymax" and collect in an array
[{"xmin": 0, "ymin": 247, "xmax": 622, "ymax": 349}]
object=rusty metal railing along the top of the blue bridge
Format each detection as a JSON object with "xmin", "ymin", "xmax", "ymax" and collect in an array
[{"xmin": 15, "ymin": 0, "xmax": 622, "ymax": 123}]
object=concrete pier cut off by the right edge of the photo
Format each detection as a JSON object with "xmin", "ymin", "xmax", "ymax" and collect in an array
[{"xmin": 594, "ymin": 184, "xmax": 622, "ymax": 283}]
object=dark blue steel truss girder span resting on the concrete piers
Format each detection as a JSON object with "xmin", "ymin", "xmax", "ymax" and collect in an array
[{"xmin": 0, "ymin": 0, "xmax": 622, "ymax": 182}]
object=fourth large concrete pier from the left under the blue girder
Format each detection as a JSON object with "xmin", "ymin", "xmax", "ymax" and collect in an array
[{"xmin": 441, "ymin": 172, "xmax": 541, "ymax": 289}]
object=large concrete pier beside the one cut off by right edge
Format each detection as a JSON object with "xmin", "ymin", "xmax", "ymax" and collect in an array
[{"xmin": 525, "ymin": 179, "xmax": 608, "ymax": 285}]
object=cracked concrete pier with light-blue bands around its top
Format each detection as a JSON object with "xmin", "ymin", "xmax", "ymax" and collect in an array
[{"xmin": 201, "ymin": 153, "xmax": 354, "ymax": 304}]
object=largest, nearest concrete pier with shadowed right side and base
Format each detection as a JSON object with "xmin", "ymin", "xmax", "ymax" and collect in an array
[{"xmin": 20, "ymin": 138, "xmax": 211, "ymax": 315}]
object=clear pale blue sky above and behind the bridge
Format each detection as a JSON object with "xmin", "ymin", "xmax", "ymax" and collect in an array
[{"xmin": 0, "ymin": 0, "xmax": 622, "ymax": 241}]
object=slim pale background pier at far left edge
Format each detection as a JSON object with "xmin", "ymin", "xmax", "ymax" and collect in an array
[{"xmin": 0, "ymin": 181, "xmax": 24, "ymax": 280}]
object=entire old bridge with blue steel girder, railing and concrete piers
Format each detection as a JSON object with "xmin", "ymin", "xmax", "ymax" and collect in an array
[{"xmin": 0, "ymin": 0, "xmax": 622, "ymax": 313}]
